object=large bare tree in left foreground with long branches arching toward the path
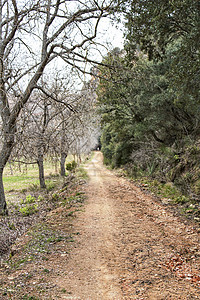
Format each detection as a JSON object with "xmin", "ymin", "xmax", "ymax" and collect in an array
[{"xmin": 0, "ymin": 0, "xmax": 113, "ymax": 214}]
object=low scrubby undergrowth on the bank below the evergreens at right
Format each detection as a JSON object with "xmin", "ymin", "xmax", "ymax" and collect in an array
[{"xmin": 115, "ymin": 143, "xmax": 200, "ymax": 226}]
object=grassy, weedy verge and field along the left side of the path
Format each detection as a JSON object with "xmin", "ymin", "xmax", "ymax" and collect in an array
[{"xmin": 0, "ymin": 156, "xmax": 89, "ymax": 300}]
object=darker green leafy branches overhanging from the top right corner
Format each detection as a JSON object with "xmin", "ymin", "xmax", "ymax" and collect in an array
[{"xmin": 122, "ymin": 0, "xmax": 200, "ymax": 100}]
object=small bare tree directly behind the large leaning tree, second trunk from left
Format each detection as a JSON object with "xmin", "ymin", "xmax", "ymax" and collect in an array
[{"xmin": 10, "ymin": 92, "xmax": 56, "ymax": 188}]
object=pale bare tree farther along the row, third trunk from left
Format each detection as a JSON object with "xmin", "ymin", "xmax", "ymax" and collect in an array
[{"xmin": 47, "ymin": 79, "xmax": 100, "ymax": 176}]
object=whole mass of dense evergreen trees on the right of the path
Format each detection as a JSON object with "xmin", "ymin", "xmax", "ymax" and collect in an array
[{"xmin": 98, "ymin": 0, "xmax": 200, "ymax": 197}]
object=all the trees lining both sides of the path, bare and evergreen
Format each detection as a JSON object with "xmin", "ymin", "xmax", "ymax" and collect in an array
[{"xmin": 0, "ymin": 0, "xmax": 200, "ymax": 219}]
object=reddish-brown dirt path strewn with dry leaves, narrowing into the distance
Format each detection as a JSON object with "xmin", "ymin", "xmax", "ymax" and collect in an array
[{"xmin": 2, "ymin": 152, "xmax": 200, "ymax": 300}]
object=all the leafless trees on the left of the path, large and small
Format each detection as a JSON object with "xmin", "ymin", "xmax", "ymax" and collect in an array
[{"xmin": 0, "ymin": 0, "xmax": 105, "ymax": 214}]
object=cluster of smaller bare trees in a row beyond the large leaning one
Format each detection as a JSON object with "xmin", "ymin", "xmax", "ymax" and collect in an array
[{"xmin": 9, "ymin": 76, "xmax": 99, "ymax": 183}]
